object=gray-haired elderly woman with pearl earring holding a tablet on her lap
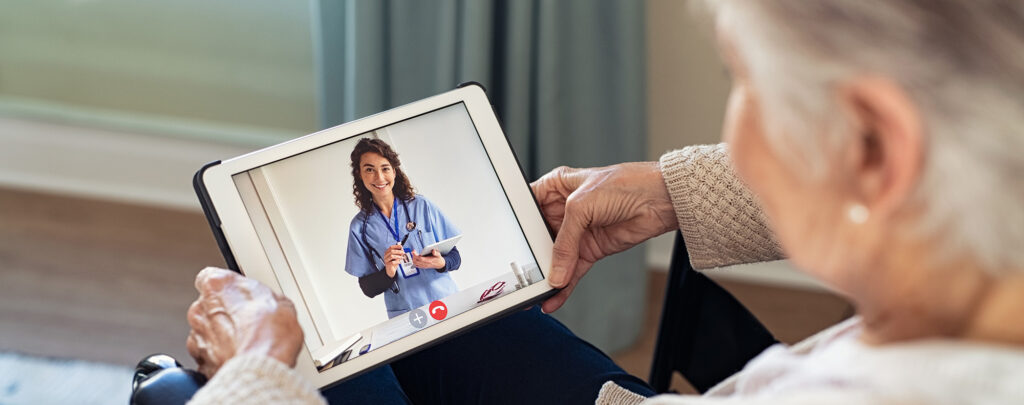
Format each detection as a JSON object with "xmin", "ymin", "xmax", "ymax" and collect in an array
[{"xmin": 189, "ymin": 0, "xmax": 1024, "ymax": 404}]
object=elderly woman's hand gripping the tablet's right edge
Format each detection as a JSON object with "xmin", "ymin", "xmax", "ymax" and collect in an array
[{"xmin": 530, "ymin": 162, "xmax": 679, "ymax": 313}]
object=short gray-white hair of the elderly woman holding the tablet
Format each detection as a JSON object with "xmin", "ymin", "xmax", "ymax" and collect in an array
[{"xmin": 709, "ymin": 0, "xmax": 1024, "ymax": 273}]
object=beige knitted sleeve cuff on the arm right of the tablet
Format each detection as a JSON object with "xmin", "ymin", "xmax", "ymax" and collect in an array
[{"xmin": 660, "ymin": 144, "xmax": 783, "ymax": 269}]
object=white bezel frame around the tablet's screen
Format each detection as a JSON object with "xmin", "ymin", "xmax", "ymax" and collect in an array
[{"xmin": 199, "ymin": 85, "xmax": 556, "ymax": 389}]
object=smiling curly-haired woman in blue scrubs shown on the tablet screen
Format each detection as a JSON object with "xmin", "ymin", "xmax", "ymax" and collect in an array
[{"xmin": 345, "ymin": 138, "xmax": 462, "ymax": 318}]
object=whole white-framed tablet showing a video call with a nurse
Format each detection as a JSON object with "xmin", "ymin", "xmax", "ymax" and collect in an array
[{"xmin": 194, "ymin": 84, "xmax": 554, "ymax": 388}]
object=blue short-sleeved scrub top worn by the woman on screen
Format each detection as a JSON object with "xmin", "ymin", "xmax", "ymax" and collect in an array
[{"xmin": 345, "ymin": 194, "xmax": 461, "ymax": 318}]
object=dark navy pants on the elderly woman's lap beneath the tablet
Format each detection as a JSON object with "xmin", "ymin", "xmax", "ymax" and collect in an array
[{"xmin": 324, "ymin": 307, "xmax": 654, "ymax": 404}]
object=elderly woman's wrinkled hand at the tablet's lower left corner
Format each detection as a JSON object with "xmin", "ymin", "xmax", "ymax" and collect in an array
[{"xmin": 186, "ymin": 267, "xmax": 302, "ymax": 378}]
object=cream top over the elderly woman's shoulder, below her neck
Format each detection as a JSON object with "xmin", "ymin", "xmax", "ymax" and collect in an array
[{"xmin": 709, "ymin": 324, "xmax": 1024, "ymax": 404}]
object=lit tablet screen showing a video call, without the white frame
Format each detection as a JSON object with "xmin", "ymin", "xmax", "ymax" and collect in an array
[{"xmin": 226, "ymin": 102, "xmax": 544, "ymax": 372}]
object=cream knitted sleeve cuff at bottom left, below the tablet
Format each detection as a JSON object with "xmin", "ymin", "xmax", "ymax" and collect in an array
[{"xmin": 188, "ymin": 355, "xmax": 326, "ymax": 405}]
